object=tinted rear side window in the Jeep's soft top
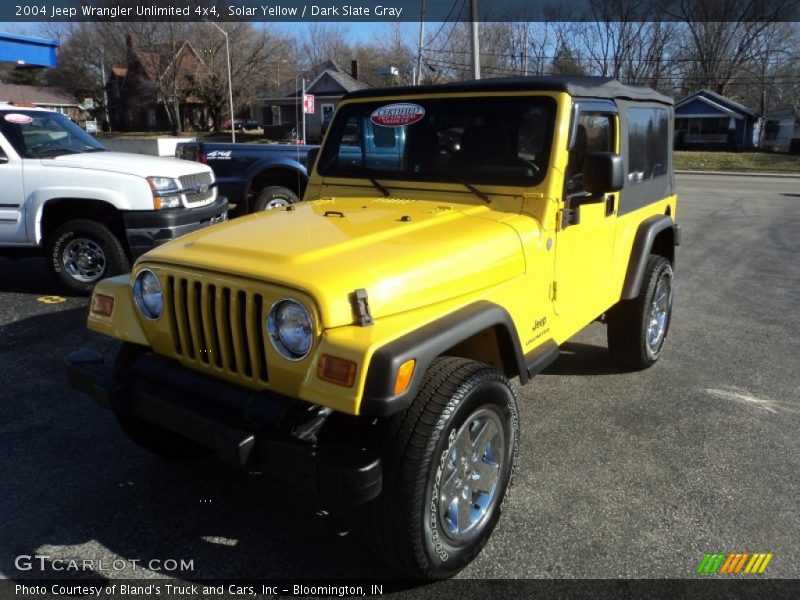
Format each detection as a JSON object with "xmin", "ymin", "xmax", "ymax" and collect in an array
[{"xmin": 628, "ymin": 108, "xmax": 670, "ymax": 183}]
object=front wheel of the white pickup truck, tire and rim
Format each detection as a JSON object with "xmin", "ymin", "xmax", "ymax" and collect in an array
[{"xmin": 47, "ymin": 219, "xmax": 130, "ymax": 294}]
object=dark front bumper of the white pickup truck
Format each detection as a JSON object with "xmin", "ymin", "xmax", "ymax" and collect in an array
[{"xmin": 122, "ymin": 196, "xmax": 228, "ymax": 260}]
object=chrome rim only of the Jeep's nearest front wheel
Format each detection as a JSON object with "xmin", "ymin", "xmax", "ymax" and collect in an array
[{"xmin": 438, "ymin": 408, "xmax": 506, "ymax": 542}]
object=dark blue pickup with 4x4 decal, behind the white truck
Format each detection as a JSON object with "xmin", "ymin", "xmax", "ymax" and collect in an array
[{"xmin": 175, "ymin": 142, "xmax": 317, "ymax": 216}]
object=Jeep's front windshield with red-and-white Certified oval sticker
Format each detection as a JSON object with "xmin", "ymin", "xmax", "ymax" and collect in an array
[{"xmin": 318, "ymin": 96, "xmax": 556, "ymax": 187}]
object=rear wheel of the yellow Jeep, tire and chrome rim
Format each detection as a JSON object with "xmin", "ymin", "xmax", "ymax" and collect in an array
[{"xmin": 607, "ymin": 255, "xmax": 673, "ymax": 370}]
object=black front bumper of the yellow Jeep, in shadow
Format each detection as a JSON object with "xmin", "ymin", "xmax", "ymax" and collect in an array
[{"xmin": 66, "ymin": 350, "xmax": 382, "ymax": 505}]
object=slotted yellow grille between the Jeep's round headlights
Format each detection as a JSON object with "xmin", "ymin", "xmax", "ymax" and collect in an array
[{"xmin": 164, "ymin": 275, "xmax": 269, "ymax": 383}]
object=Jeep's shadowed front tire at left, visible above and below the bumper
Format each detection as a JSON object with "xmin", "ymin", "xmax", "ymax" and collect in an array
[{"xmin": 114, "ymin": 342, "xmax": 211, "ymax": 460}]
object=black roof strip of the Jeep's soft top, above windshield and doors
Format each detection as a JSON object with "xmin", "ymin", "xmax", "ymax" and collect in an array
[{"xmin": 344, "ymin": 75, "xmax": 675, "ymax": 106}]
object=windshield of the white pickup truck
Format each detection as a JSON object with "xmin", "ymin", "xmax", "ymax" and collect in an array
[{"xmin": 0, "ymin": 110, "xmax": 105, "ymax": 158}]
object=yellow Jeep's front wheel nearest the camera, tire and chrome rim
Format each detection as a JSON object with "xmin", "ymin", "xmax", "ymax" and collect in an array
[{"xmin": 368, "ymin": 357, "xmax": 519, "ymax": 579}]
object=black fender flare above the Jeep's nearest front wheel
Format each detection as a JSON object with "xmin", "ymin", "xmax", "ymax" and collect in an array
[{"xmin": 359, "ymin": 301, "xmax": 558, "ymax": 417}]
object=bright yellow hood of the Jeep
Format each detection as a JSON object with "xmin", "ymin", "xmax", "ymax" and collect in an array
[{"xmin": 140, "ymin": 198, "xmax": 525, "ymax": 327}]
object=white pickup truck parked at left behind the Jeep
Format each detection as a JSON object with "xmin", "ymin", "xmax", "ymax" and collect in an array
[{"xmin": 0, "ymin": 104, "xmax": 228, "ymax": 293}]
